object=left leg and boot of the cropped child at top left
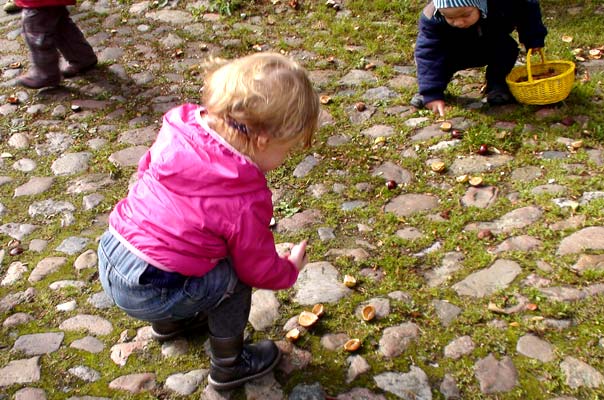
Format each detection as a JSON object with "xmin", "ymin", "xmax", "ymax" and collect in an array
[{"xmin": 17, "ymin": 7, "xmax": 61, "ymax": 89}]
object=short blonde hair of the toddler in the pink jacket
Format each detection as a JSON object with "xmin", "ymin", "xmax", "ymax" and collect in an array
[{"xmin": 203, "ymin": 53, "xmax": 320, "ymax": 154}]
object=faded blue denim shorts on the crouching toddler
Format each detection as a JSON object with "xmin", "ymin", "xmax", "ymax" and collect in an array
[{"xmin": 98, "ymin": 231, "xmax": 238, "ymax": 321}]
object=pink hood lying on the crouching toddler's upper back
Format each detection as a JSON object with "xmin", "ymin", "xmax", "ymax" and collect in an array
[{"xmin": 149, "ymin": 104, "xmax": 266, "ymax": 197}]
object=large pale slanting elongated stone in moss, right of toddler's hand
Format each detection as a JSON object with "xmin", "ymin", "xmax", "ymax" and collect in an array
[{"xmin": 453, "ymin": 259, "xmax": 522, "ymax": 297}]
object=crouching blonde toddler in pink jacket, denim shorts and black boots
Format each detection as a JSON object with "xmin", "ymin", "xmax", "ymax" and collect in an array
[{"xmin": 98, "ymin": 54, "xmax": 320, "ymax": 390}]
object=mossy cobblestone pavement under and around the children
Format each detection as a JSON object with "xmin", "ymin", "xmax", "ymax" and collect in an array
[{"xmin": 0, "ymin": 0, "xmax": 604, "ymax": 400}]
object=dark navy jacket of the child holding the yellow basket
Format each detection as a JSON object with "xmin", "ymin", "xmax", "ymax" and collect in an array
[{"xmin": 415, "ymin": 0, "xmax": 547, "ymax": 103}]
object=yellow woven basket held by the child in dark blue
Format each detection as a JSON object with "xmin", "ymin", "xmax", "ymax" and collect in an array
[{"xmin": 505, "ymin": 49, "xmax": 575, "ymax": 105}]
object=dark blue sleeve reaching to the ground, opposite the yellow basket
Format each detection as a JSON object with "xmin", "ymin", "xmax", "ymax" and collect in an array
[{"xmin": 415, "ymin": 12, "xmax": 449, "ymax": 103}]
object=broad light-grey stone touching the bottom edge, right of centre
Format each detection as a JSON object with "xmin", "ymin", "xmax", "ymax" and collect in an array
[{"xmin": 373, "ymin": 365, "xmax": 432, "ymax": 400}]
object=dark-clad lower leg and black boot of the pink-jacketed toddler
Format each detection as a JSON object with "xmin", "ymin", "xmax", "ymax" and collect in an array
[{"xmin": 208, "ymin": 262, "xmax": 281, "ymax": 390}]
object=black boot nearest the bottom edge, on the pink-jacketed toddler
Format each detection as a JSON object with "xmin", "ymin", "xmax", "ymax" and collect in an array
[{"xmin": 208, "ymin": 335, "xmax": 281, "ymax": 390}]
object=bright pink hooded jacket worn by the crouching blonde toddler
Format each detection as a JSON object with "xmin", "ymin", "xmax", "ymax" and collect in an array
[{"xmin": 109, "ymin": 104, "xmax": 298, "ymax": 289}]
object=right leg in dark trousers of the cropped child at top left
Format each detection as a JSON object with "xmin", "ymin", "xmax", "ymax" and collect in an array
[{"xmin": 56, "ymin": 8, "xmax": 98, "ymax": 78}]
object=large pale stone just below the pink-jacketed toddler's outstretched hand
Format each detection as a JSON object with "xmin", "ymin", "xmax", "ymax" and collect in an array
[{"xmin": 293, "ymin": 261, "xmax": 352, "ymax": 305}]
